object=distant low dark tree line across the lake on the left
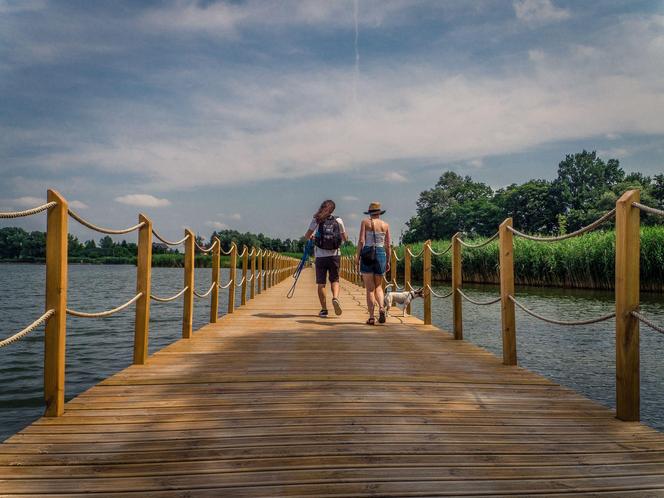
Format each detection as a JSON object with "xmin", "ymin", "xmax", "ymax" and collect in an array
[{"xmin": 0, "ymin": 227, "xmax": 305, "ymax": 263}]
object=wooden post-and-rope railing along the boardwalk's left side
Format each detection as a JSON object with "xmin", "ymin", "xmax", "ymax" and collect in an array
[{"xmin": 0, "ymin": 190, "xmax": 298, "ymax": 417}]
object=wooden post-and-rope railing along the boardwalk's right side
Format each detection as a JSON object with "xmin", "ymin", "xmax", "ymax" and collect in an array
[{"xmin": 341, "ymin": 190, "xmax": 664, "ymax": 421}]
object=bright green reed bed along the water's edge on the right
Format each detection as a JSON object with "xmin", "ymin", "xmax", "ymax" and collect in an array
[{"xmin": 397, "ymin": 227, "xmax": 664, "ymax": 292}]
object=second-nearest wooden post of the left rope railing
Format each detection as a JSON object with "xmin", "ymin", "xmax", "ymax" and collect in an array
[{"xmin": 134, "ymin": 214, "xmax": 152, "ymax": 365}]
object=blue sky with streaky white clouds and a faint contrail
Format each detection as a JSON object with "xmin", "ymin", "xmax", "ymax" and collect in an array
[{"xmin": 0, "ymin": 0, "xmax": 664, "ymax": 240}]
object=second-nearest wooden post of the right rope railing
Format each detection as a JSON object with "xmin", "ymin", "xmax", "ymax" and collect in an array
[{"xmin": 498, "ymin": 218, "xmax": 517, "ymax": 365}]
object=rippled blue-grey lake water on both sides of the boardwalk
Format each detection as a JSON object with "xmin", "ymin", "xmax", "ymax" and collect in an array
[{"xmin": 0, "ymin": 264, "xmax": 664, "ymax": 441}]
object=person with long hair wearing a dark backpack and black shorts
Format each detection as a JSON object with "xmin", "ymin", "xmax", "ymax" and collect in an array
[{"xmin": 304, "ymin": 199, "xmax": 348, "ymax": 318}]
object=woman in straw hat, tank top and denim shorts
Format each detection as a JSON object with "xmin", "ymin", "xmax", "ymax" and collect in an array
[{"xmin": 356, "ymin": 202, "xmax": 390, "ymax": 325}]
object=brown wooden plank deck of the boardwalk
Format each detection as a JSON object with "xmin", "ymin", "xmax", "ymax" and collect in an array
[{"xmin": 0, "ymin": 270, "xmax": 664, "ymax": 497}]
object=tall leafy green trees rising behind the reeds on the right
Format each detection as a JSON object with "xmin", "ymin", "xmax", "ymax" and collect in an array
[{"xmin": 402, "ymin": 150, "xmax": 664, "ymax": 243}]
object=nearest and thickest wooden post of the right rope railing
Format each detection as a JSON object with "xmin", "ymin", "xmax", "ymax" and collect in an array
[{"xmin": 616, "ymin": 190, "xmax": 641, "ymax": 422}]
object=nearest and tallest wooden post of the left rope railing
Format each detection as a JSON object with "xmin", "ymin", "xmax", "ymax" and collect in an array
[{"xmin": 44, "ymin": 190, "xmax": 69, "ymax": 417}]
